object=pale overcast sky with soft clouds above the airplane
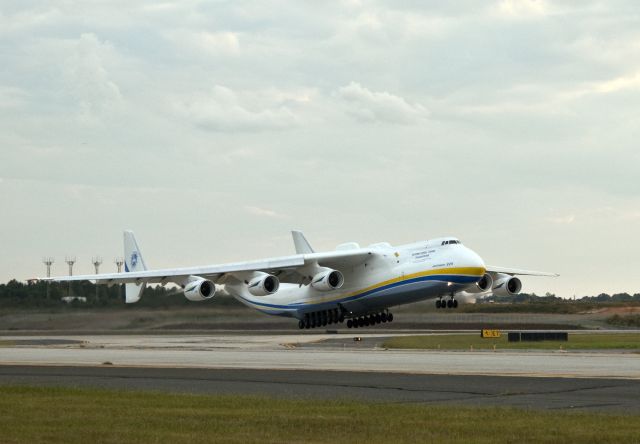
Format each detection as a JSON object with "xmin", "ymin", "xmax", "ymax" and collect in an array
[{"xmin": 0, "ymin": 0, "xmax": 640, "ymax": 297}]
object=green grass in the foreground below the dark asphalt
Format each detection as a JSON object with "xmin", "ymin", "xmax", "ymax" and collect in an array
[{"xmin": 0, "ymin": 386, "xmax": 640, "ymax": 444}]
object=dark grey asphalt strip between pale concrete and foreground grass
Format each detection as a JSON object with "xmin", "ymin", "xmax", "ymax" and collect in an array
[{"xmin": 0, "ymin": 366, "xmax": 640, "ymax": 414}]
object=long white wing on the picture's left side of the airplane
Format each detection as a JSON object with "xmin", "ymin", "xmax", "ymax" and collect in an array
[{"xmin": 39, "ymin": 250, "xmax": 373, "ymax": 285}]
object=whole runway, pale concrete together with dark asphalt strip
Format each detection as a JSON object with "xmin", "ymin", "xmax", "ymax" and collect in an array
[{"xmin": 0, "ymin": 335, "xmax": 640, "ymax": 413}]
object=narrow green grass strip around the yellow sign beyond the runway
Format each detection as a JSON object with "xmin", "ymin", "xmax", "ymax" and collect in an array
[{"xmin": 382, "ymin": 332, "xmax": 640, "ymax": 350}]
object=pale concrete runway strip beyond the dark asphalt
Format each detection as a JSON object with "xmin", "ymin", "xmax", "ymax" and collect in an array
[{"xmin": 0, "ymin": 335, "xmax": 640, "ymax": 379}]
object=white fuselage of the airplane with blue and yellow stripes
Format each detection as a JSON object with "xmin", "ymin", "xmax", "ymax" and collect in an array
[{"xmin": 225, "ymin": 238, "xmax": 485, "ymax": 319}]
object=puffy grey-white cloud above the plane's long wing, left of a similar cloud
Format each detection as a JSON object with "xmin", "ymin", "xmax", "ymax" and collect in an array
[{"xmin": 178, "ymin": 85, "xmax": 300, "ymax": 132}]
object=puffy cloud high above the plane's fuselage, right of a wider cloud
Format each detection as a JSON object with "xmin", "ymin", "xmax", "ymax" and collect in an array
[{"xmin": 335, "ymin": 82, "xmax": 429, "ymax": 125}]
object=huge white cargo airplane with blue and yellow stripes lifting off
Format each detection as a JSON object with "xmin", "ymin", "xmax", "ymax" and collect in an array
[{"xmin": 42, "ymin": 231, "xmax": 558, "ymax": 329}]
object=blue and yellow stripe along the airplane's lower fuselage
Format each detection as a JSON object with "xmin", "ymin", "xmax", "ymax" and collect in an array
[{"xmin": 236, "ymin": 267, "xmax": 485, "ymax": 316}]
